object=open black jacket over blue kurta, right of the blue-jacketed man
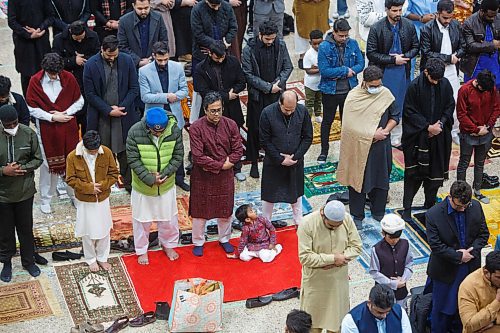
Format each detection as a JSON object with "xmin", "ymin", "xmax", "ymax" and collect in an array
[{"xmin": 366, "ymin": 17, "xmax": 419, "ymax": 78}]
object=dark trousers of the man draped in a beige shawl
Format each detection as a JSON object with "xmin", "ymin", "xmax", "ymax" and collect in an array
[{"xmin": 349, "ymin": 186, "xmax": 389, "ymax": 221}]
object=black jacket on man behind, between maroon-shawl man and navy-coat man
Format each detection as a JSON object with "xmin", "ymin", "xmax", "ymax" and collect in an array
[{"xmin": 52, "ymin": 28, "xmax": 101, "ymax": 91}]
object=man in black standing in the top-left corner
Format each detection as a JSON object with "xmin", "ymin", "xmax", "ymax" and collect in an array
[{"xmin": 7, "ymin": 0, "xmax": 54, "ymax": 97}]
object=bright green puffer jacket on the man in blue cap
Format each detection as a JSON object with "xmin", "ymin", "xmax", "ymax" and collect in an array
[{"xmin": 127, "ymin": 116, "xmax": 183, "ymax": 196}]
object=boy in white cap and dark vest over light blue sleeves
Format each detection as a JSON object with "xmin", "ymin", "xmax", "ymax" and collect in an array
[{"xmin": 369, "ymin": 214, "xmax": 413, "ymax": 309}]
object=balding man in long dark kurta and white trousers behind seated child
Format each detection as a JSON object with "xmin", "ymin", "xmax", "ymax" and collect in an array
[{"xmin": 259, "ymin": 90, "xmax": 313, "ymax": 225}]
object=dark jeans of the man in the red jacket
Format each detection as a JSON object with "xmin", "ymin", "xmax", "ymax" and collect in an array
[{"xmin": 457, "ymin": 135, "xmax": 491, "ymax": 191}]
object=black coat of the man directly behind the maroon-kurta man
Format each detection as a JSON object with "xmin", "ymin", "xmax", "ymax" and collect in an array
[{"xmin": 193, "ymin": 55, "xmax": 246, "ymax": 127}]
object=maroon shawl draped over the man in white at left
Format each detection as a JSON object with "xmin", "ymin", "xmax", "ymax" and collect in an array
[{"xmin": 26, "ymin": 70, "xmax": 80, "ymax": 175}]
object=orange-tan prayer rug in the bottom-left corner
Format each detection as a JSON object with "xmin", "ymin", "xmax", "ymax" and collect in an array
[{"xmin": 0, "ymin": 278, "xmax": 61, "ymax": 324}]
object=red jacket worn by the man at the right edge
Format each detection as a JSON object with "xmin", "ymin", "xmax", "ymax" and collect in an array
[{"xmin": 456, "ymin": 80, "xmax": 500, "ymax": 134}]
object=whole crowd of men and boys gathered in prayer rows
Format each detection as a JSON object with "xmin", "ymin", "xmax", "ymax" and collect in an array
[{"xmin": 0, "ymin": 0, "xmax": 500, "ymax": 333}]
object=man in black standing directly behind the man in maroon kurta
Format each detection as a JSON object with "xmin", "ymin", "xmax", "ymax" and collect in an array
[{"xmin": 193, "ymin": 41, "xmax": 246, "ymax": 181}]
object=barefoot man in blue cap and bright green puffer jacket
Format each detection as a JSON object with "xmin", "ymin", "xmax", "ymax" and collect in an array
[{"xmin": 127, "ymin": 108, "xmax": 184, "ymax": 265}]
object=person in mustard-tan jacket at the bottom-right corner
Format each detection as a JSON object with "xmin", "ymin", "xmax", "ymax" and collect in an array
[{"xmin": 458, "ymin": 251, "xmax": 500, "ymax": 333}]
